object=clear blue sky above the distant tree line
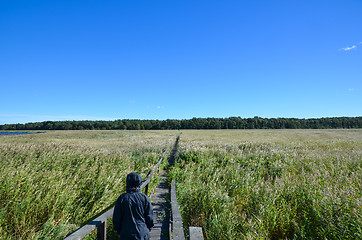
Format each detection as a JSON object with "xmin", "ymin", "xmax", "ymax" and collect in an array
[{"xmin": 0, "ymin": 0, "xmax": 362, "ymax": 124}]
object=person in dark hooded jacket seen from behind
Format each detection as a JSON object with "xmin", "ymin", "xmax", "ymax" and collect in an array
[{"xmin": 113, "ymin": 173, "xmax": 153, "ymax": 240}]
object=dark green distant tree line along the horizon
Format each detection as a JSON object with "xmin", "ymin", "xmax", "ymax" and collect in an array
[{"xmin": 0, "ymin": 117, "xmax": 362, "ymax": 130}]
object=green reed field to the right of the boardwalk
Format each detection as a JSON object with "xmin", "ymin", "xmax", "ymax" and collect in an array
[{"xmin": 170, "ymin": 129, "xmax": 362, "ymax": 239}]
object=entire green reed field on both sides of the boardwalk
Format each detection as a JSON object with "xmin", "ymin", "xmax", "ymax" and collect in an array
[{"xmin": 0, "ymin": 130, "xmax": 362, "ymax": 239}]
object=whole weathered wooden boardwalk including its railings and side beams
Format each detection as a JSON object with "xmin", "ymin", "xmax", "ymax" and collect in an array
[{"xmin": 64, "ymin": 136, "xmax": 203, "ymax": 240}]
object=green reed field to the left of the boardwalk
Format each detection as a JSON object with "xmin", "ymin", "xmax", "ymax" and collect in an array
[{"xmin": 0, "ymin": 131, "xmax": 176, "ymax": 239}]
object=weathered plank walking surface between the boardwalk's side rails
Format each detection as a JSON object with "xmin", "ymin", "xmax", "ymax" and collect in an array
[{"xmin": 151, "ymin": 139, "xmax": 178, "ymax": 240}]
